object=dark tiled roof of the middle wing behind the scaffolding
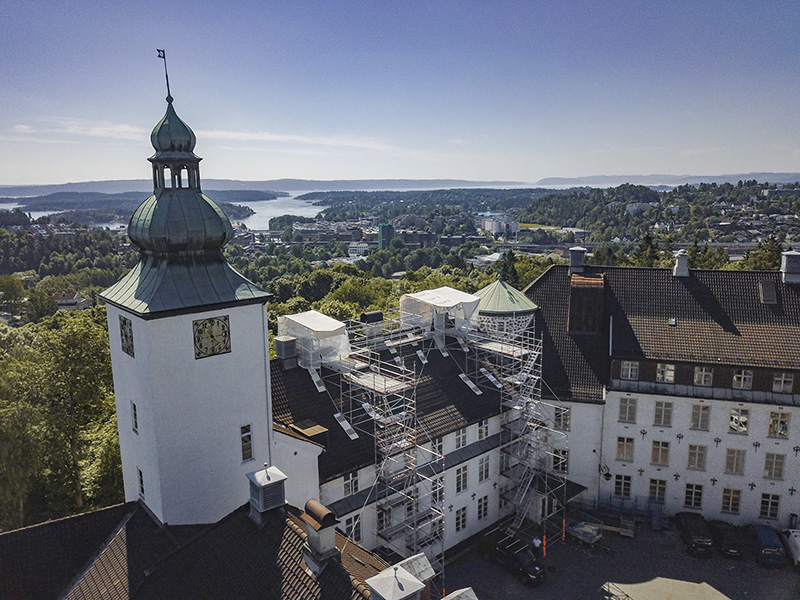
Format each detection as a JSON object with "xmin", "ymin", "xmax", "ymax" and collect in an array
[{"xmin": 271, "ymin": 342, "xmax": 500, "ymax": 482}]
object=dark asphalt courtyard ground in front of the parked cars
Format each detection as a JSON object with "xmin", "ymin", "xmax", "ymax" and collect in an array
[{"xmin": 445, "ymin": 524, "xmax": 800, "ymax": 600}]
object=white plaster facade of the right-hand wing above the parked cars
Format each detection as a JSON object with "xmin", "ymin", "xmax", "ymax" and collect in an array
[{"xmin": 601, "ymin": 392, "xmax": 800, "ymax": 528}]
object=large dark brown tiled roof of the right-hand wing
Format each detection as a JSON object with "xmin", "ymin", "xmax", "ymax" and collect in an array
[{"xmin": 525, "ymin": 265, "xmax": 800, "ymax": 402}]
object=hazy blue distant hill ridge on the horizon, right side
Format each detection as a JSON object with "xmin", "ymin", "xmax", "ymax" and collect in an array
[{"xmin": 535, "ymin": 172, "xmax": 800, "ymax": 188}]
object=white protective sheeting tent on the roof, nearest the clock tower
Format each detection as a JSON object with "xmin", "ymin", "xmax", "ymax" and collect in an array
[{"xmin": 278, "ymin": 310, "xmax": 350, "ymax": 369}]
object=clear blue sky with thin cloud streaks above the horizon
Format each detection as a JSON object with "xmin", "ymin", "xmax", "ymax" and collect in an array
[{"xmin": 0, "ymin": 0, "xmax": 800, "ymax": 185}]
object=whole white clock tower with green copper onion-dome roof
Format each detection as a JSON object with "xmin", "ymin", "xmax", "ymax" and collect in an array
[{"xmin": 101, "ymin": 93, "xmax": 271, "ymax": 525}]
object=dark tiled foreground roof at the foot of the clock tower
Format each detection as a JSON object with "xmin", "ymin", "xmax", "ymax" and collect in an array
[{"xmin": 0, "ymin": 503, "xmax": 387, "ymax": 600}]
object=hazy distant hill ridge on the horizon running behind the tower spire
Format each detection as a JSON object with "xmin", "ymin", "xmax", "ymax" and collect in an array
[{"xmin": 0, "ymin": 179, "xmax": 527, "ymax": 197}]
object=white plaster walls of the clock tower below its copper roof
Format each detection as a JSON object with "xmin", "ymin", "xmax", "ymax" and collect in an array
[{"xmin": 108, "ymin": 304, "xmax": 271, "ymax": 524}]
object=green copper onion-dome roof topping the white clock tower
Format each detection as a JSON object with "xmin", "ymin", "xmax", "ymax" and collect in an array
[{"xmin": 101, "ymin": 96, "xmax": 269, "ymax": 318}]
